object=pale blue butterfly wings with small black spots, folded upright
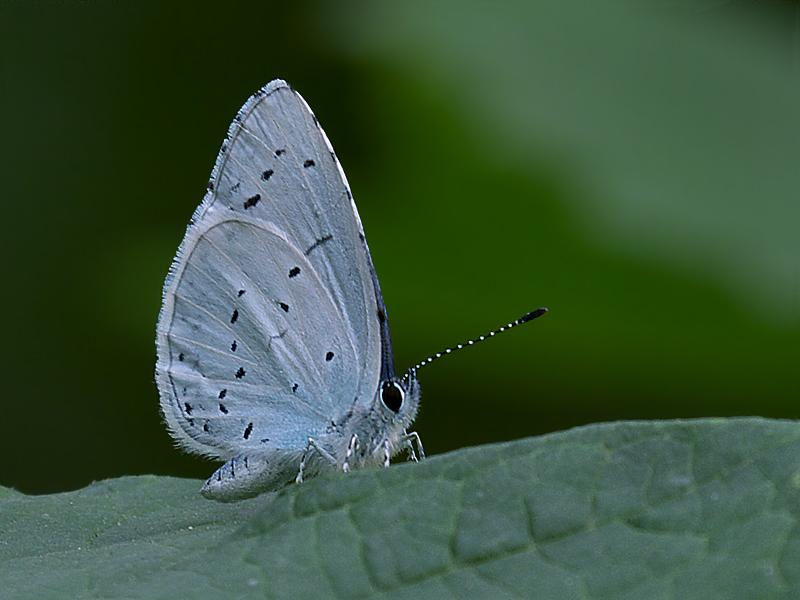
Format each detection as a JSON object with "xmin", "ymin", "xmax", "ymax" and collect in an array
[{"xmin": 156, "ymin": 81, "xmax": 383, "ymax": 462}]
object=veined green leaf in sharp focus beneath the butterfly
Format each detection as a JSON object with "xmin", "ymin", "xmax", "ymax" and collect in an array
[{"xmin": 0, "ymin": 419, "xmax": 800, "ymax": 600}]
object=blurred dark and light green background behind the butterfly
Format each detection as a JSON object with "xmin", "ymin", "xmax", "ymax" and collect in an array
[{"xmin": 0, "ymin": 0, "xmax": 800, "ymax": 492}]
